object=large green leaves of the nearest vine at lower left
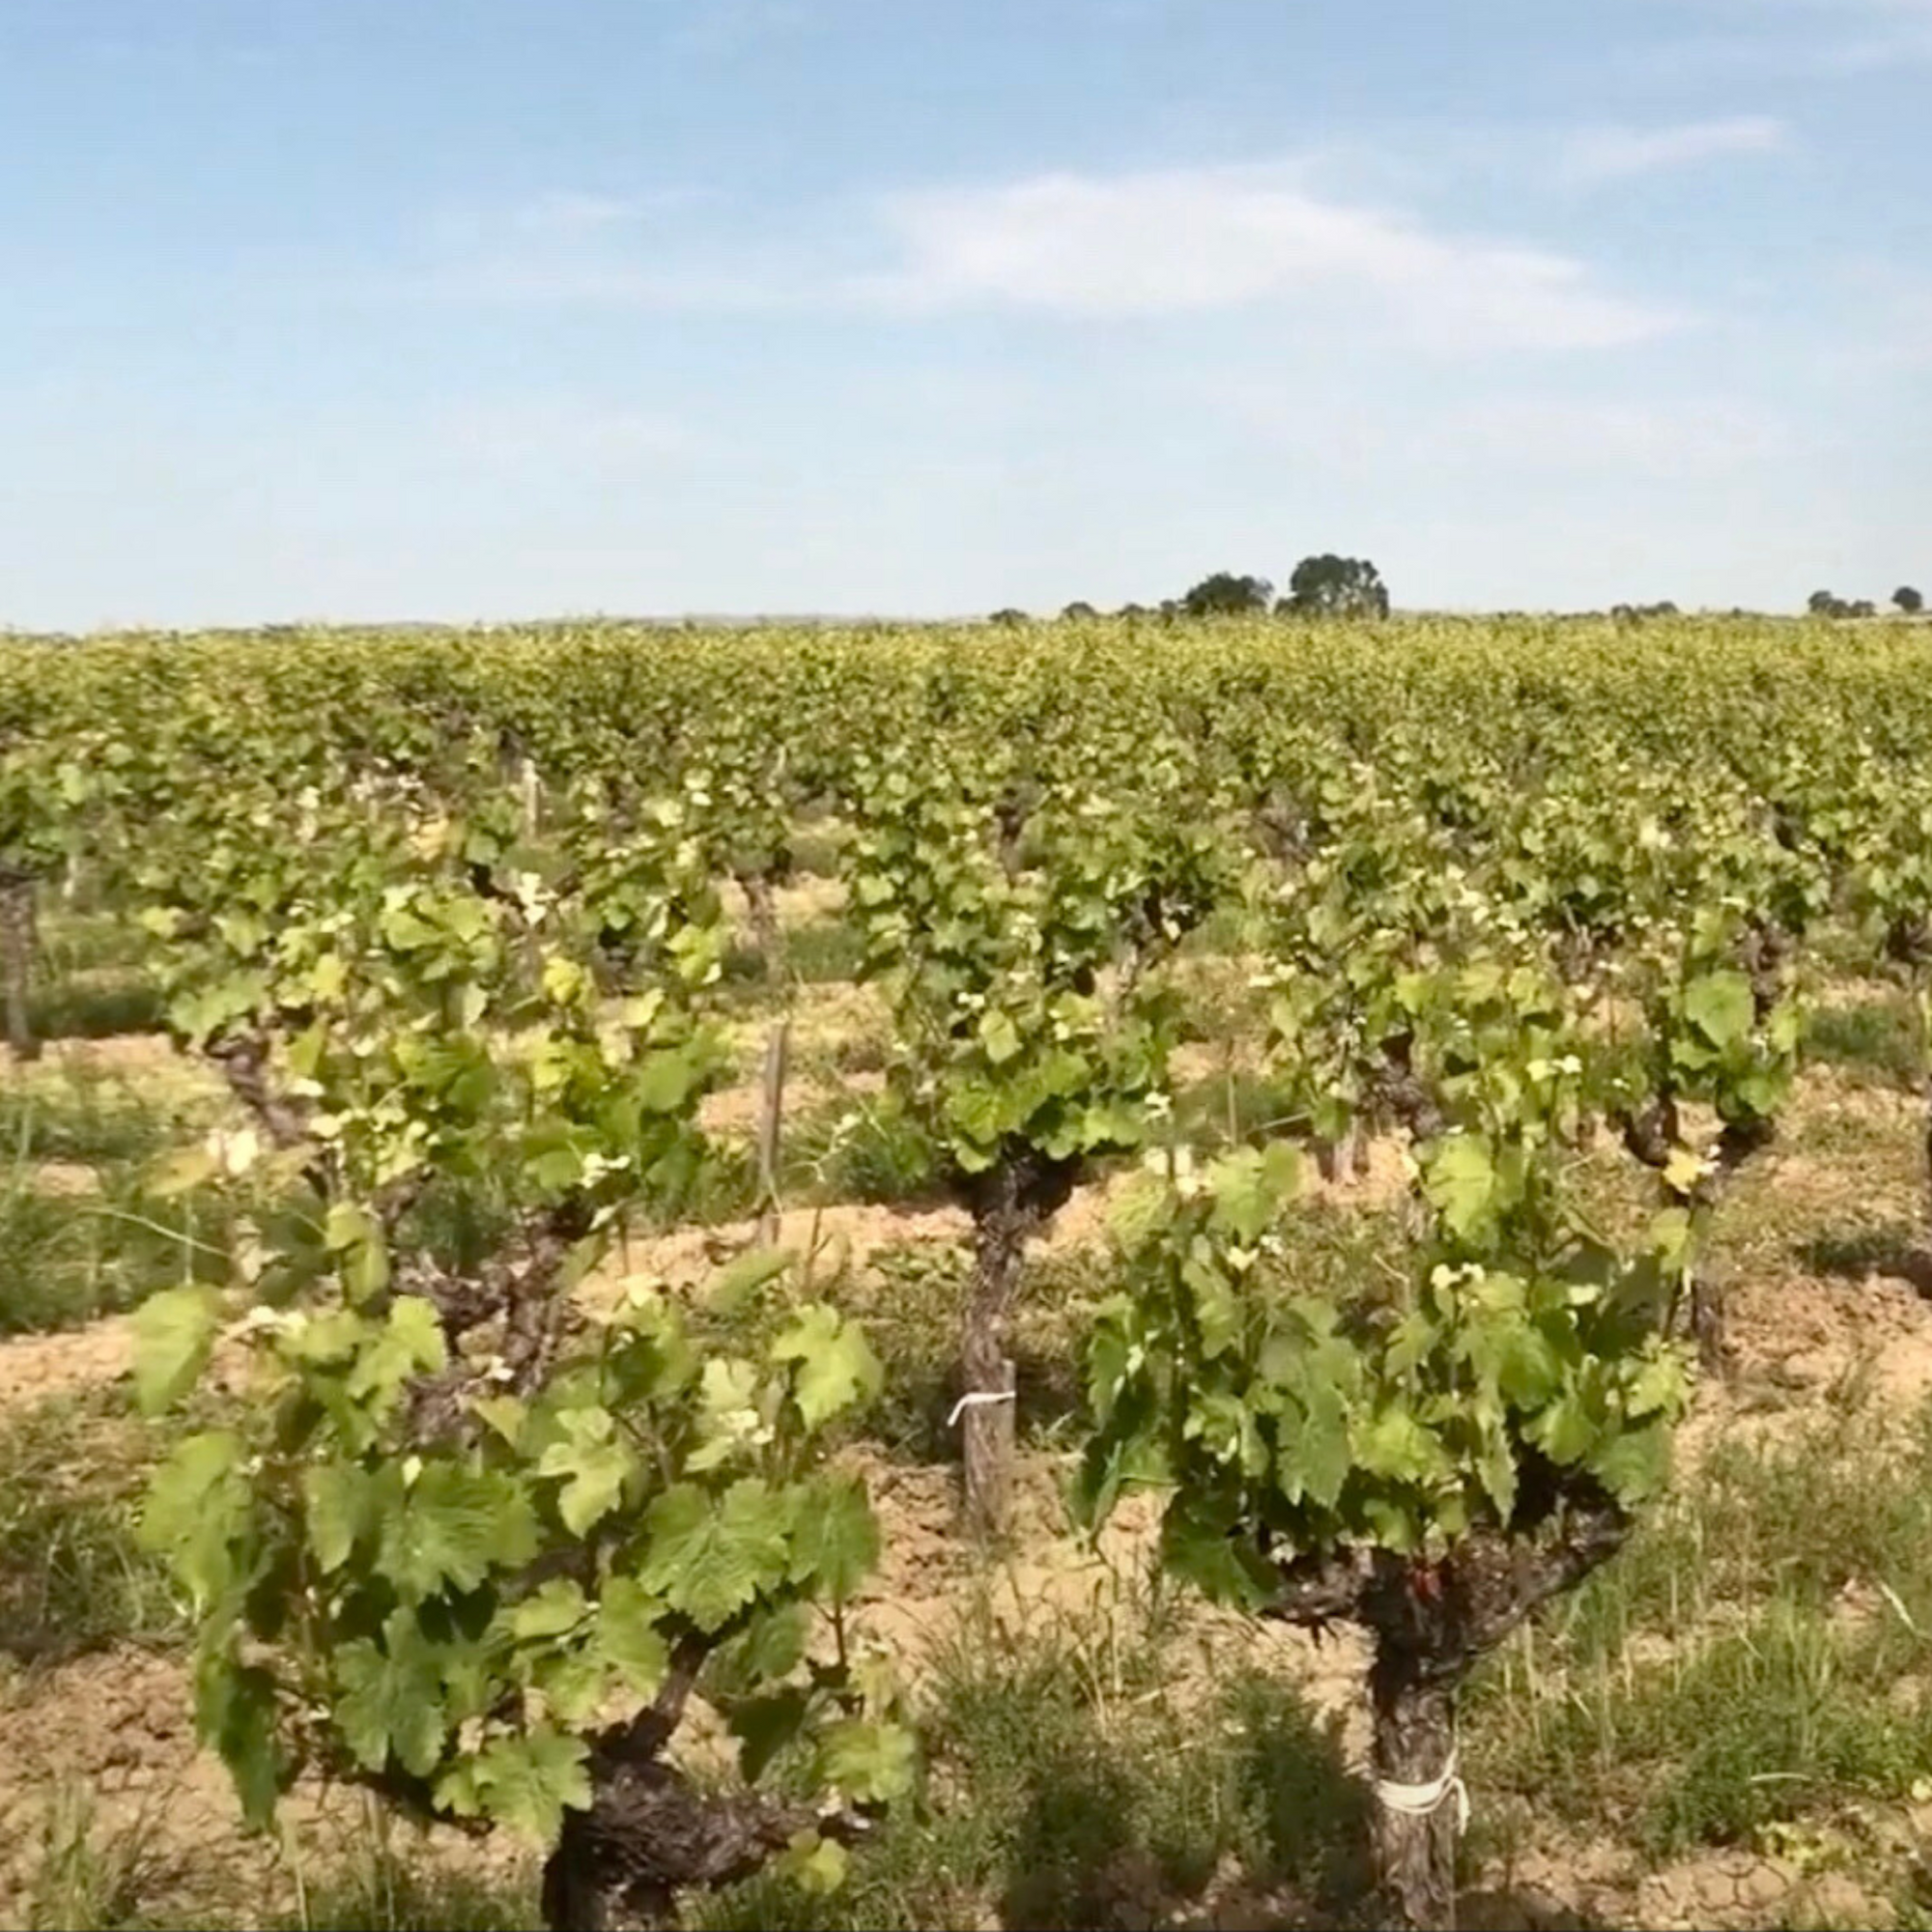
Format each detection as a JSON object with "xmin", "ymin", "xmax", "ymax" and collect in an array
[{"xmin": 145, "ymin": 1252, "xmax": 908, "ymax": 1841}]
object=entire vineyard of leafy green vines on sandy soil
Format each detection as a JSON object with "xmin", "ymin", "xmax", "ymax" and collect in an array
[{"xmin": 0, "ymin": 616, "xmax": 1932, "ymax": 1928}]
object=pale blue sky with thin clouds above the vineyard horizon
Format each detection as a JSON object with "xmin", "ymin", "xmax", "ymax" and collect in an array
[{"xmin": 0, "ymin": 0, "xmax": 1932, "ymax": 628}]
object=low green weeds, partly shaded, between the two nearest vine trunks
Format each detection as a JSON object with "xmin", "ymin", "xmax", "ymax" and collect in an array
[{"xmin": 699, "ymin": 1594, "xmax": 1362, "ymax": 1932}]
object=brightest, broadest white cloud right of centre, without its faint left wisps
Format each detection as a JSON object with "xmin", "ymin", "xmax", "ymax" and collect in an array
[{"xmin": 852, "ymin": 166, "xmax": 1687, "ymax": 348}]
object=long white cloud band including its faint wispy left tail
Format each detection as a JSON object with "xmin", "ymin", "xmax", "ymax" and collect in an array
[{"xmin": 392, "ymin": 162, "xmax": 1692, "ymax": 352}]
